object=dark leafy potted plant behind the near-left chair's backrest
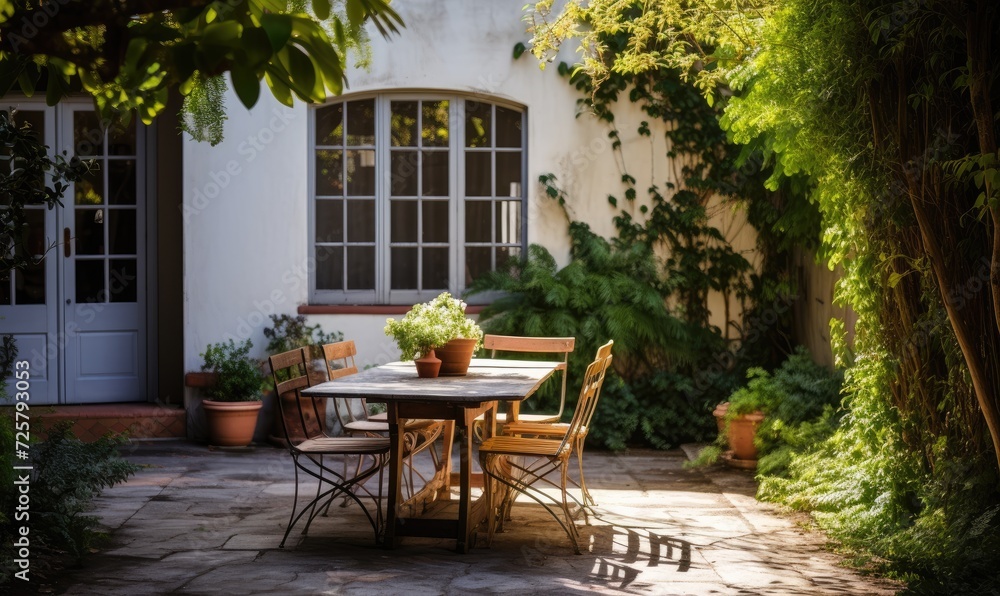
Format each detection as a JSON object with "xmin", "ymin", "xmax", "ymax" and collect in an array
[{"xmin": 264, "ymin": 314, "xmax": 344, "ymax": 445}]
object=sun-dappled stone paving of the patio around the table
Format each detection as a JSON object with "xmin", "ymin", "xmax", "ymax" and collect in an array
[{"xmin": 55, "ymin": 441, "xmax": 899, "ymax": 596}]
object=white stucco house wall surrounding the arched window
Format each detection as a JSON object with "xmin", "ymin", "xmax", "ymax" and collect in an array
[{"xmin": 184, "ymin": 0, "xmax": 756, "ymax": 386}]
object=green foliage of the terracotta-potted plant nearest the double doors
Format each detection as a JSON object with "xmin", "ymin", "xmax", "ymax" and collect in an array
[{"xmin": 201, "ymin": 339, "xmax": 264, "ymax": 401}]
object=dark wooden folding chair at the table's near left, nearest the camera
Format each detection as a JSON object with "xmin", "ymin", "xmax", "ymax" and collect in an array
[{"xmin": 268, "ymin": 348, "xmax": 389, "ymax": 548}]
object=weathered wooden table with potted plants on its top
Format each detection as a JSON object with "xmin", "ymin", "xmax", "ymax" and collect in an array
[{"xmin": 302, "ymin": 359, "xmax": 559, "ymax": 552}]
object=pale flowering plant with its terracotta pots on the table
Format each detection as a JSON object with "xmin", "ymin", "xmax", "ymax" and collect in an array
[{"xmin": 385, "ymin": 292, "xmax": 483, "ymax": 377}]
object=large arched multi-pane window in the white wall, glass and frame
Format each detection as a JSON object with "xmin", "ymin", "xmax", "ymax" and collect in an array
[{"xmin": 310, "ymin": 94, "xmax": 526, "ymax": 304}]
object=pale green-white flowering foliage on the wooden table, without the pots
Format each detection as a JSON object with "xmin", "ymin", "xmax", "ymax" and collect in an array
[{"xmin": 385, "ymin": 292, "xmax": 483, "ymax": 360}]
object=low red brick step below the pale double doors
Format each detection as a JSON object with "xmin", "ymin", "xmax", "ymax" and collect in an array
[{"xmin": 32, "ymin": 403, "xmax": 187, "ymax": 441}]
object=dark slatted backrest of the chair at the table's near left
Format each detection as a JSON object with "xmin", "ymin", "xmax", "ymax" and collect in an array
[{"xmin": 267, "ymin": 348, "xmax": 322, "ymax": 448}]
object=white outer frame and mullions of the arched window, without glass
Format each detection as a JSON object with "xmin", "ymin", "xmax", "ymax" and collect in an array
[{"xmin": 308, "ymin": 92, "xmax": 528, "ymax": 305}]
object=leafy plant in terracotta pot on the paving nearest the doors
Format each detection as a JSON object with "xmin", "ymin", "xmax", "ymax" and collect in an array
[{"xmin": 201, "ymin": 339, "xmax": 264, "ymax": 447}]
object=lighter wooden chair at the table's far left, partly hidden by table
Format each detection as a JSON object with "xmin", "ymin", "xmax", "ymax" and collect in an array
[{"xmin": 323, "ymin": 340, "xmax": 444, "ymax": 506}]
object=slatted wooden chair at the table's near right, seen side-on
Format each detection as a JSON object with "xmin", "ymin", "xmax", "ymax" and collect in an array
[{"xmin": 479, "ymin": 341, "xmax": 613, "ymax": 554}]
